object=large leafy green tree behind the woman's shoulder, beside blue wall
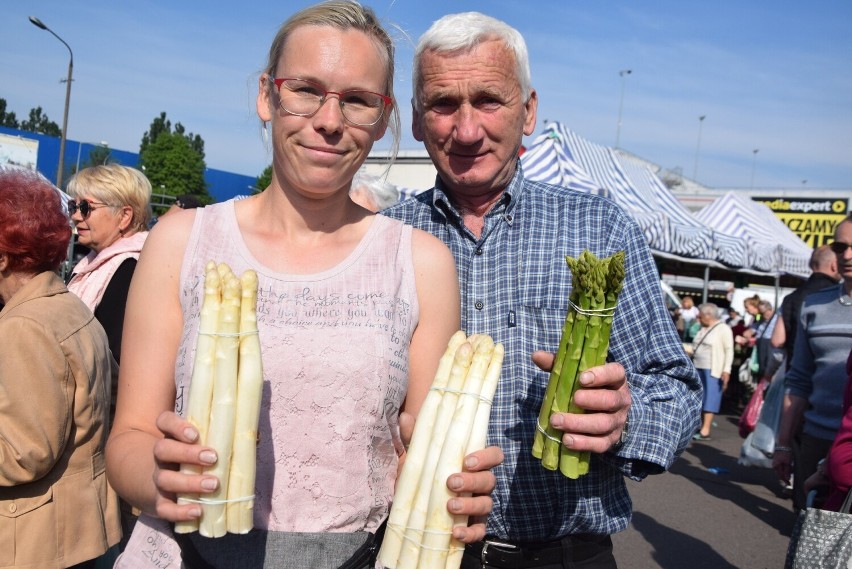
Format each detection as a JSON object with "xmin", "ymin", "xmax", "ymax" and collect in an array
[{"xmin": 139, "ymin": 112, "xmax": 212, "ymax": 203}]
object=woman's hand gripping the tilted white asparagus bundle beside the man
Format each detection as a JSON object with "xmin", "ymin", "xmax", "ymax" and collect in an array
[{"xmin": 397, "ymin": 411, "xmax": 503, "ymax": 543}]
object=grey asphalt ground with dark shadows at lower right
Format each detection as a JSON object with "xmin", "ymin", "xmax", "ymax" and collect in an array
[{"xmin": 613, "ymin": 411, "xmax": 795, "ymax": 569}]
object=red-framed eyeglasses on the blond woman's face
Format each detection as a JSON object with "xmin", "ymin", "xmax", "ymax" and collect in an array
[{"xmin": 269, "ymin": 77, "xmax": 393, "ymax": 126}]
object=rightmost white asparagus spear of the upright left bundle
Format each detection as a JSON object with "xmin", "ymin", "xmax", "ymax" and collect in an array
[{"xmin": 226, "ymin": 270, "xmax": 263, "ymax": 533}]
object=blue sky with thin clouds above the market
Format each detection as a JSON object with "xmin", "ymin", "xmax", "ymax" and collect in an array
[{"xmin": 0, "ymin": 0, "xmax": 852, "ymax": 188}]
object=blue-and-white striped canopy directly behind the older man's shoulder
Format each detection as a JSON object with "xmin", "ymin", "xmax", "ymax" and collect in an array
[{"xmin": 521, "ymin": 122, "xmax": 747, "ymax": 268}]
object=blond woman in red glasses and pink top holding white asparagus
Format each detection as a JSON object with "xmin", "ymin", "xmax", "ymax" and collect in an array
[{"xmin": 107, "ymin": 1, "xmax": 500, "ymax": 569}]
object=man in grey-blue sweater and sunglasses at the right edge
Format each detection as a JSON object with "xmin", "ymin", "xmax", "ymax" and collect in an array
[{"xmin": 772, "ymin": 214, "xmax": 852, "ymax": 510}]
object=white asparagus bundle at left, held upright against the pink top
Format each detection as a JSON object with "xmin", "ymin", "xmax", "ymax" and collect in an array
[{"xmin": 175, "ymin": 261, "xmax": 263, "ymax": 537}]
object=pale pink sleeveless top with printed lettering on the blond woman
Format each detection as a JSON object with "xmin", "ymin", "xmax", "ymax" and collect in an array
[{"xmin": 175, "ymin": 201, "xmax": 418, "ymax": 532}]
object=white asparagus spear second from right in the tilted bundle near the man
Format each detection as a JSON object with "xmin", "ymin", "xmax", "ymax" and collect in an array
[{"xmin": 418, "ymin": 336, "xmax": 494, "ymax": 569}]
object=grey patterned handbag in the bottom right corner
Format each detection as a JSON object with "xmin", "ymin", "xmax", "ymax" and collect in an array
[{"xmin": 784, "ymin": 489, "xmax": 852, "ymax": 569}]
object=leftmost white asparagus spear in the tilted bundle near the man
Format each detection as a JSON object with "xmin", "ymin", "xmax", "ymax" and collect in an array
[{"xmin": 379, "ymin": 330, "xmax": 465, "ymax": 569}]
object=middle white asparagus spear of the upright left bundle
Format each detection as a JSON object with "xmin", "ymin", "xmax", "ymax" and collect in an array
[{"xmin": 199, "ymin": 263, "xmax": 240, "ymax": 537}]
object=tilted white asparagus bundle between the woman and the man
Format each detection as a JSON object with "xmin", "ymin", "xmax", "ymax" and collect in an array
[{"xmin": 379, "ymin": 331, "xmax": 503, "ymax": 569}]
